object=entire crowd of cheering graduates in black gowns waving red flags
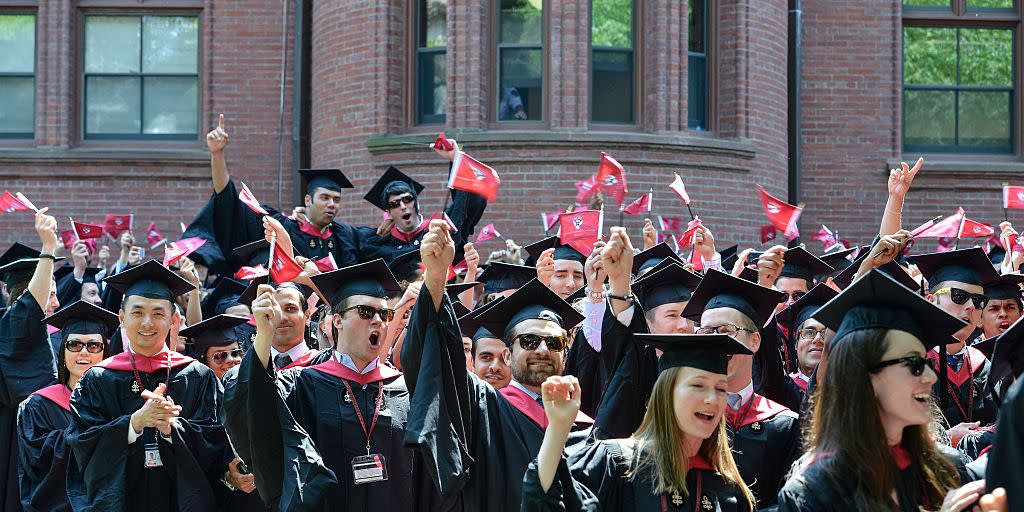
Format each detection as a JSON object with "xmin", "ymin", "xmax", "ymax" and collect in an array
[{"xmin": 0, "ymin": 117, "xmax": 1024, "ymax": 512}]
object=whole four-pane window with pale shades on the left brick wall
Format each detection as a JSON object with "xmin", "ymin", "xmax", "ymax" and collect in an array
[{"xmin": 83, "ymin": 15, "xmax": 199, "ymax": 139}]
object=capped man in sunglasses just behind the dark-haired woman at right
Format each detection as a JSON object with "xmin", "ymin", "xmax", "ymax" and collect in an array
[{"xmin": 914, "ymin": 247, "xmax": 999, "ymax": 428}]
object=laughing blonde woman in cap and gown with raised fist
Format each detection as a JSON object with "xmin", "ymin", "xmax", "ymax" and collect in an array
[{"xmin": 522, "ymin": 334, "xmax": 754, "ymax": 512}]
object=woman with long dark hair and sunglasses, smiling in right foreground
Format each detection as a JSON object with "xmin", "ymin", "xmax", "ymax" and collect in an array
[{"xmin": 778, "ymin": 270, "xmax": 984, "ymax": 512}]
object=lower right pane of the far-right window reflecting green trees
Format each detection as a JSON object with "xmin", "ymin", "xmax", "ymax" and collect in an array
[{"xmin": 958, "ymin": 91, "xmax": 1013, "ymax": 152}]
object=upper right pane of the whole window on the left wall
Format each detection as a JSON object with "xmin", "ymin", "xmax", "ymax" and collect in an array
[{"xmin": 142, "ymin": 16, "xmax": 199, "ymax": 74}]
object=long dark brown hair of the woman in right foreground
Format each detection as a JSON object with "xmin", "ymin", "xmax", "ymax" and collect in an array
[{"xmin": 806, "ymin": 329, "xmax": 958, "ymax": 510}]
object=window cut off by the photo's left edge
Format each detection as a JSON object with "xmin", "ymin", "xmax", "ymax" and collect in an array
[{"xmin": 0, "ymin": 14, "xmax": 36, "ymax": 138}]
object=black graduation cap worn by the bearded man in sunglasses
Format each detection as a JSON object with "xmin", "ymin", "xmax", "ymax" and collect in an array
[{"xmin": 477, "ymin": 279, "xmax": 583, "ymax": 343}]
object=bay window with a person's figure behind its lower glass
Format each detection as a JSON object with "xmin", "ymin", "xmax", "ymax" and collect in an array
[{"xmin": 498, "ymin": 0, "xmax": 544, "ymax": 121}]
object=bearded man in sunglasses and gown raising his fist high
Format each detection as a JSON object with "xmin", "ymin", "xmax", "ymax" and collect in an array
[{"xmin": 401, "ymin": 221, "xmax": 591, "ymax": 512}]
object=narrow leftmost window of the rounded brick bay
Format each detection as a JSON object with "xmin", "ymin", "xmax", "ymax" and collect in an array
[{"xmin": 416, "ymin": 0, "xmax": 447, "ymax": 124}]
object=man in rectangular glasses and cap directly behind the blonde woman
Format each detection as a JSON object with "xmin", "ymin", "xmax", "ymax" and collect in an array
[{"xmin": 683, "ymin": 270, "xmax": 801, "ymax": 508}]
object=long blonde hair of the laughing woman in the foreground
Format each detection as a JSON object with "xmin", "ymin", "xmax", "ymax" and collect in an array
[{"xmin": 627, "ymin": 367, "xmax": 755, "ymax": 509}]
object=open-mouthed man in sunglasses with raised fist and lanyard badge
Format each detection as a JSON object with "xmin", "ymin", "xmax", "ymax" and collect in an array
[{"xmin": 222, "ymin": 259, "xmax": 453, "ymax": 510}]
